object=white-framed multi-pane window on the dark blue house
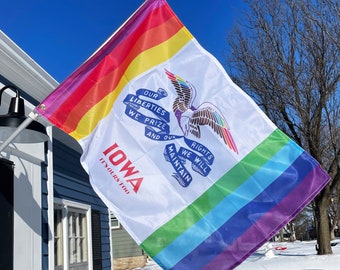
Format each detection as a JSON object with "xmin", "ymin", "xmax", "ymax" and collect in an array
[{"xmin": 54, "ymin": 200, "xmax": 92, "ymax": 270}]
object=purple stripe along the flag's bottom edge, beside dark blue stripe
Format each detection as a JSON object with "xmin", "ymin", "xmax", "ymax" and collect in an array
[{"xmin": 204, "ymin": 166, "xmax": 329, "ymax": 269}]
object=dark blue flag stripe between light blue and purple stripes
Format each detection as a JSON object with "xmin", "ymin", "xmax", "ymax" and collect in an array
[{"xmin": 171, "ymin": 152, "xmax": 317, "ymax": 270}]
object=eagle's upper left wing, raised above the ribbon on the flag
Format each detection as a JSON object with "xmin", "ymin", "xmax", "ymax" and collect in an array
[{"xmin": 165, "ymin": 70, "xmax": 194, "ymax": 112}]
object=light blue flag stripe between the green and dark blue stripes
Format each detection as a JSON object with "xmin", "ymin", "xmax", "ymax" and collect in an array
[{"xmin": 153, "ymin": 140, "xmax": 303, "ymax": 268}]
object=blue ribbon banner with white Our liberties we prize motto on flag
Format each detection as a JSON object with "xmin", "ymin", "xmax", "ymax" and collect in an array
[{"xmin": 123, "ymin": 88, "xmax": 214, "ymax": 187}]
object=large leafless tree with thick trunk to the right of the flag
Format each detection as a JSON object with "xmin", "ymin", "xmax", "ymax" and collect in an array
[{"xmin": 228, "ymin": 0, "xmax": 340, "ymax": 254}]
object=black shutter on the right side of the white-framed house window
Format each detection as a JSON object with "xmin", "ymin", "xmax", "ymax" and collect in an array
[{"xmin": 91, "ymin": 210, "xmax": 102, "ymax": 270}]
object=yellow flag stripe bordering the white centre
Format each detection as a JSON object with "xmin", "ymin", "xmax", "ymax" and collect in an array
[{"xmin": 69, "ymin": 27, "xmax": 193, "ymax": 140}]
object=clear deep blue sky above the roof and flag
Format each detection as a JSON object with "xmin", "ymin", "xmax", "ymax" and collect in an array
[{"xmin": 0, "ymin": 0, "xmax": 244, "ymax": 82}]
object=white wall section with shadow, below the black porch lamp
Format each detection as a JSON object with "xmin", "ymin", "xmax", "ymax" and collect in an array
[{"xmin": 2, "ymin": 143, "xmax": 44, "ymax": 270}]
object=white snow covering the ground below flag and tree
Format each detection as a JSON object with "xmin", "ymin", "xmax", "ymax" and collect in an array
[{"xmin": 136, "ymin": 239, "xmax": 340, "ymax": 270}]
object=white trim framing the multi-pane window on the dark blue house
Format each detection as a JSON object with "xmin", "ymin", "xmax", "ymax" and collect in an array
[{"xmin": 53, "ymin": 198, "xmax": 93, "ymax": 270}]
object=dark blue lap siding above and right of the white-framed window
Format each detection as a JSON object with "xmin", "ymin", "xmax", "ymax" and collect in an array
[{"xmin": 53, "ymin": 140, "xmax": 111, "ymax": 270}]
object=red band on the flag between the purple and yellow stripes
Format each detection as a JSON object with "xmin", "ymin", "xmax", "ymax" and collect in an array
[{"xmin": 51, "ymin": 3, "xmax": 180, "ymax": 131}]
